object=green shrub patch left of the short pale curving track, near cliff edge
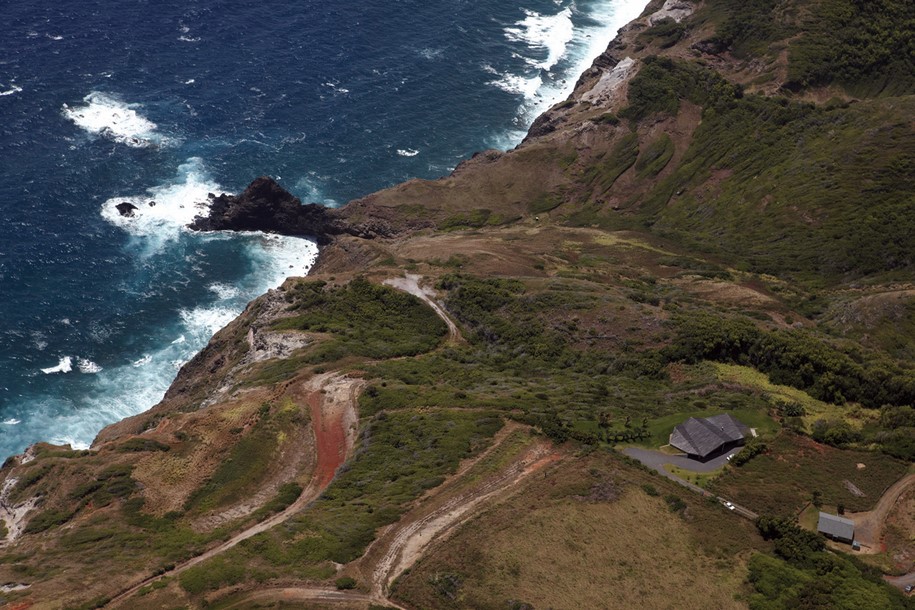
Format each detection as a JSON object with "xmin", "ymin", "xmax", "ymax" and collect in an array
[{"xmin": 274, "ymin": 278, "xmax": 447, "ymax": 362}]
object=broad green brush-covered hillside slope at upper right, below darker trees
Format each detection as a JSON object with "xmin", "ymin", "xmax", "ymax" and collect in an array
[{"xmin": 600, "ymin": 58, "xmax": 915, "ymax": 285}]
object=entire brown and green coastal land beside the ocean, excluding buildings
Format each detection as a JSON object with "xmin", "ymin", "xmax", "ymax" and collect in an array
[{"xmin": 0, "ymin": 0, "xmax": 915, "ymax": 609}]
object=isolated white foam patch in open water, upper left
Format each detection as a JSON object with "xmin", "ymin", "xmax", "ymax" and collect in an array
[{"xmin": 63, "ymin": 91, "xmax": 166, "ymax": 148}]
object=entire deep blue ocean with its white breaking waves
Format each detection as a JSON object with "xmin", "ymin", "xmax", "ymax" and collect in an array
[{"xmin": 0, "ymin": 0, "xmax": 646, "ymax": 460}]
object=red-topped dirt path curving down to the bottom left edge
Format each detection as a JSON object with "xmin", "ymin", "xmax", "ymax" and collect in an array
[{"xmin": 108, "ymin": 373, "xmax": 364, "ymax": 607}]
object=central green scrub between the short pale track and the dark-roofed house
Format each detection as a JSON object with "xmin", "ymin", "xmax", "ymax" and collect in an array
[{"xmin": 360, "ymin": 274, "xmax": 780, "ymax": 443}]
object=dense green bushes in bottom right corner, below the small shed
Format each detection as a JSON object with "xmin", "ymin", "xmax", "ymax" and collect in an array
[{"xmin": 749, "ymin": 517, "xmax": 912, "ymax": 610}]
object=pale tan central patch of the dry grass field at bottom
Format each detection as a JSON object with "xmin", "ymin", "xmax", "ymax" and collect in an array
[{"xmin": 467, "ymin": 490, "xmax": 744, "ymax": 610}]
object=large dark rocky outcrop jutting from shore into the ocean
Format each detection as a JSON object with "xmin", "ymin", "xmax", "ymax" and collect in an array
[{"xmin": 188, "ymin": 176, "xmax": 366, "ymax": 244}]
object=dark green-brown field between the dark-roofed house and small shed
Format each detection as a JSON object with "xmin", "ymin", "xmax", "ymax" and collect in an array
[{"xmin": 710, "ymin": 432, "xmax": 908, "ymax": 516}]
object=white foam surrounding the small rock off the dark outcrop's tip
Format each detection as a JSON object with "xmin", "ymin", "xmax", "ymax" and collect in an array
[{"xmin": 102, "ymin": 157, "xmax": 222, "ymax": 249}]
